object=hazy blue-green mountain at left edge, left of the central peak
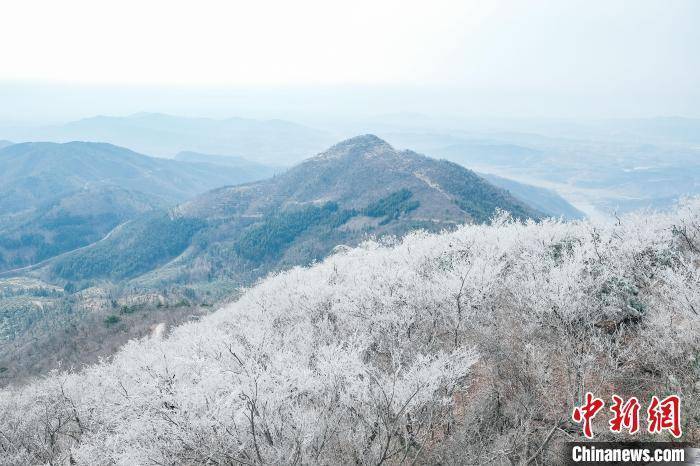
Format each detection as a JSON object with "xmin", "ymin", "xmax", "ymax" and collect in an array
[{"xmin": 0, "ymin": 142, "xmax": 272, "ymax": 272}]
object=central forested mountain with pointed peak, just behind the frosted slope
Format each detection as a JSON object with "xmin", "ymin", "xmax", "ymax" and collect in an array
[{"xmin": 45, "ymin": 135, "xmax": 543, "ymax": 284}]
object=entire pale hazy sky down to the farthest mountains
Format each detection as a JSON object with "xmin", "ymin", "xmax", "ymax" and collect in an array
[{"xmin": 0, "ymin": 0, "xmax": 700, "ymax": 119}]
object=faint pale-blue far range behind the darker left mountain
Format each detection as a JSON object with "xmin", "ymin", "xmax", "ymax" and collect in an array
[{"xmin": 4, "ymin": 113, "xmax": 333, "ymax": 166}]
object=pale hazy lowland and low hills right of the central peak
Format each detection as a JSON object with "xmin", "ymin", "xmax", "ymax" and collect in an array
[{"xmin": 382, "ymin": 126, "xmax": 700, "ymax": 218}]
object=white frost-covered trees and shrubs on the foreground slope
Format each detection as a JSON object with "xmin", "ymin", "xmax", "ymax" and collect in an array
[{"xmin": 0, "ymin": 200, "xmax": 700, "ymax": 465}]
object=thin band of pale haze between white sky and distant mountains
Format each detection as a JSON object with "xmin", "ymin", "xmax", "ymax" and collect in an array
[{"xmin": 0, "ymin": 80, "xmax": 700, "ymax": 125}]
